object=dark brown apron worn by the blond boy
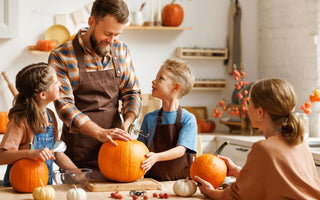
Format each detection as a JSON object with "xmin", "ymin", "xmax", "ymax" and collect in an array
[{"xmin": 145, "ymin": 106, "xmax": 193, "ymax": 181}]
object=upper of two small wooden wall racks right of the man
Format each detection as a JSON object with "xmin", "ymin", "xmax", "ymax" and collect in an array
[{"xmin": 176, "ymin": 47, "xmax": 228, "ymax": 60}]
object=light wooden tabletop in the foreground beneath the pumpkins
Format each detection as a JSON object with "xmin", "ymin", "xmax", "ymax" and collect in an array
[{"xmin": 0, "ymin": 181, "xmax": 207, "ymax": 200}]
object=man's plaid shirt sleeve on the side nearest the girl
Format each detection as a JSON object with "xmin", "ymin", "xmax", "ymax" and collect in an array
[{"xmin": 48, "ymin": 42, "xmax": 89, "ymax": 132}]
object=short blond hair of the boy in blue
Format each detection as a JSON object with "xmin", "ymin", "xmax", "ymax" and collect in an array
[{"xmin": 160, "ymin": 59, "xmax": 194, "ymax": 98}]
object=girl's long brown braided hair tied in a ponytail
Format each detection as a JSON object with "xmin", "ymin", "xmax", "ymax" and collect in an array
[{"xmin": 9, "ymin": 63, "xmax": 54, "ymax": 133}]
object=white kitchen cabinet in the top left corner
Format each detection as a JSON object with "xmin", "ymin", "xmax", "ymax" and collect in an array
[{"xmin": 0, "ymin": 0, "xmax": 19, "ymax": 38}]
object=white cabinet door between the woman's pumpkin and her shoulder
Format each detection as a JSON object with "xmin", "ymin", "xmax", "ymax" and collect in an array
[{"xmin": 221, "ymin": 143, "xmax": 250, "ymax": 167}]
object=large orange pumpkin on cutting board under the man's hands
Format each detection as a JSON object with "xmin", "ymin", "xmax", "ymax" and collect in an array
[{"xmin": 98, "ymin": 140, "xmax": 149, "ymax": 182}]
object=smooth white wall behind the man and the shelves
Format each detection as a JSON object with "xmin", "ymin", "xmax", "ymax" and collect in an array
[{"xmin": 0, "ymin": 0, "xmax": 258, "ymax": 133}]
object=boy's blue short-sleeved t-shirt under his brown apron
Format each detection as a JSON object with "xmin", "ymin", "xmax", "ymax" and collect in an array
[{"xmin": 138, "ymin": 108, "xmax": 198, "ymax": 154}]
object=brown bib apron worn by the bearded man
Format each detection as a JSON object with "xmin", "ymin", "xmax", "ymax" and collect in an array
[{"xmin": 61, "ymin": 35, "xmax": 121, "ymax": 173}]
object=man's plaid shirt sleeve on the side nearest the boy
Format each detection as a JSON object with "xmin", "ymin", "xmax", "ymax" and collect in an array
[{"xmin": 116, "ymin": 43, "xmax": 141, "ymax": 117}]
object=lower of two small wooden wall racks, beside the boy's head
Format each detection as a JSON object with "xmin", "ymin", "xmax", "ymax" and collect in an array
[{"xmin": 192, "ymin": 79, "xmax": 227, "ymax": 91}]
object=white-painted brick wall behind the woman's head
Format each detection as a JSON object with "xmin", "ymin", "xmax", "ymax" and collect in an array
[{"xmin": 258, "ymin": 0, "xmax": 320, "ymax": 136}]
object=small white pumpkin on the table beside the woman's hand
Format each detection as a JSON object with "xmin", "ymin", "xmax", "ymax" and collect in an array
[{"xmin": 173, "ymin": 177, "xmax": 197, "ymax": 197}]
